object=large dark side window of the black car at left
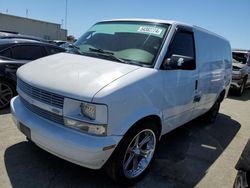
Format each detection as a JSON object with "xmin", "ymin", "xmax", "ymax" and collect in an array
[{"xmin": 12, "ymin": 45, "xmax": 44, "ymax": 60}]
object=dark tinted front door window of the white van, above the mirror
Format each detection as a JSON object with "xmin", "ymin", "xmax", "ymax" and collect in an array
[{"xmin": 167, "ymin": 31, "xmax": 195, "ymax": 58}]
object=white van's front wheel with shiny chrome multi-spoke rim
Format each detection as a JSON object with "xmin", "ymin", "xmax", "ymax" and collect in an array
[{"xmin": 104, "ymin": 121, "xmax": 159, "ymax": 185}]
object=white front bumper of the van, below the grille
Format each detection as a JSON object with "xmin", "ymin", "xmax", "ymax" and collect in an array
[{"xmin": 11, "ymin": 96, "xmax": 121, "ymax": 169}]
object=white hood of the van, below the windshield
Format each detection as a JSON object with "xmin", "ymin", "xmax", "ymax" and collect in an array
[{"xmin": 17, "ymin": 53, "xmax": 140, "ymax": 101}]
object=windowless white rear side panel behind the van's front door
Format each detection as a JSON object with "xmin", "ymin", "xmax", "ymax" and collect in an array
[{"xmin": 194, "ymin": 27, "xmax": 232, "ymax": 116}]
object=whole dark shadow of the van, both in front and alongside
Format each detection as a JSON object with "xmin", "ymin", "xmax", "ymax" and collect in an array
[{"xmin": 4, "ymin": 114, "xmax": 240, "ymax": 188}]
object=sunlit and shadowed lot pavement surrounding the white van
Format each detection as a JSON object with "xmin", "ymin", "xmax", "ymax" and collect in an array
[{"xmin": 0, "ymin": 89, "xmax": 250, "ymax": 188}]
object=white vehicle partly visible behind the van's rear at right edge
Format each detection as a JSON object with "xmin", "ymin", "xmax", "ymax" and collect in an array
[{"xmin": 230, "ymin": 50, "xmax": 250, "ymax": 96}]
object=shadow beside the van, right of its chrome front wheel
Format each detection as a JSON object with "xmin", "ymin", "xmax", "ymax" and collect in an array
[{"xmin": 148, "ymin": 114, "xmax": 241, "ymax": 187}]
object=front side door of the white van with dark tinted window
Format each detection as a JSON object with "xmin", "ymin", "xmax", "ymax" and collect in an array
[{"xmin": 161, "ymin": 27, "xmax": 199, "ymax": 133}]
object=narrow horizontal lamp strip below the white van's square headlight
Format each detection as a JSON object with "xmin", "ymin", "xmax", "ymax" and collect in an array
[{"xmin": 64, "ymin": 118, "xmax": 107, "ymax": 136}]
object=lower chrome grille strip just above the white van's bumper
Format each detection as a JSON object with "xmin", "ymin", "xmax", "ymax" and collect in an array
[{"xmin": 20, "ymin": 96, "xmax": 64, "ymax": 125}]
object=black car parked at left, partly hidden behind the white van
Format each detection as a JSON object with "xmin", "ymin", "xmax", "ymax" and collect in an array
[{"xmin": 0, "ymin": 38, "xmax": 65, "ymax": 109}]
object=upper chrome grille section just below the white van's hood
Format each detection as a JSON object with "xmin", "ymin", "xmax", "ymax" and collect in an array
[{"xmin": 17, "ymin": 79, "xmax": 64, "ymax": 109}]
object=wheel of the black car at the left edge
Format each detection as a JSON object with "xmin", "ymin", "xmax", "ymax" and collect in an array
[{"xmin": 0, "ymin": 80, "xmax": 15, "ymax": 110}]
